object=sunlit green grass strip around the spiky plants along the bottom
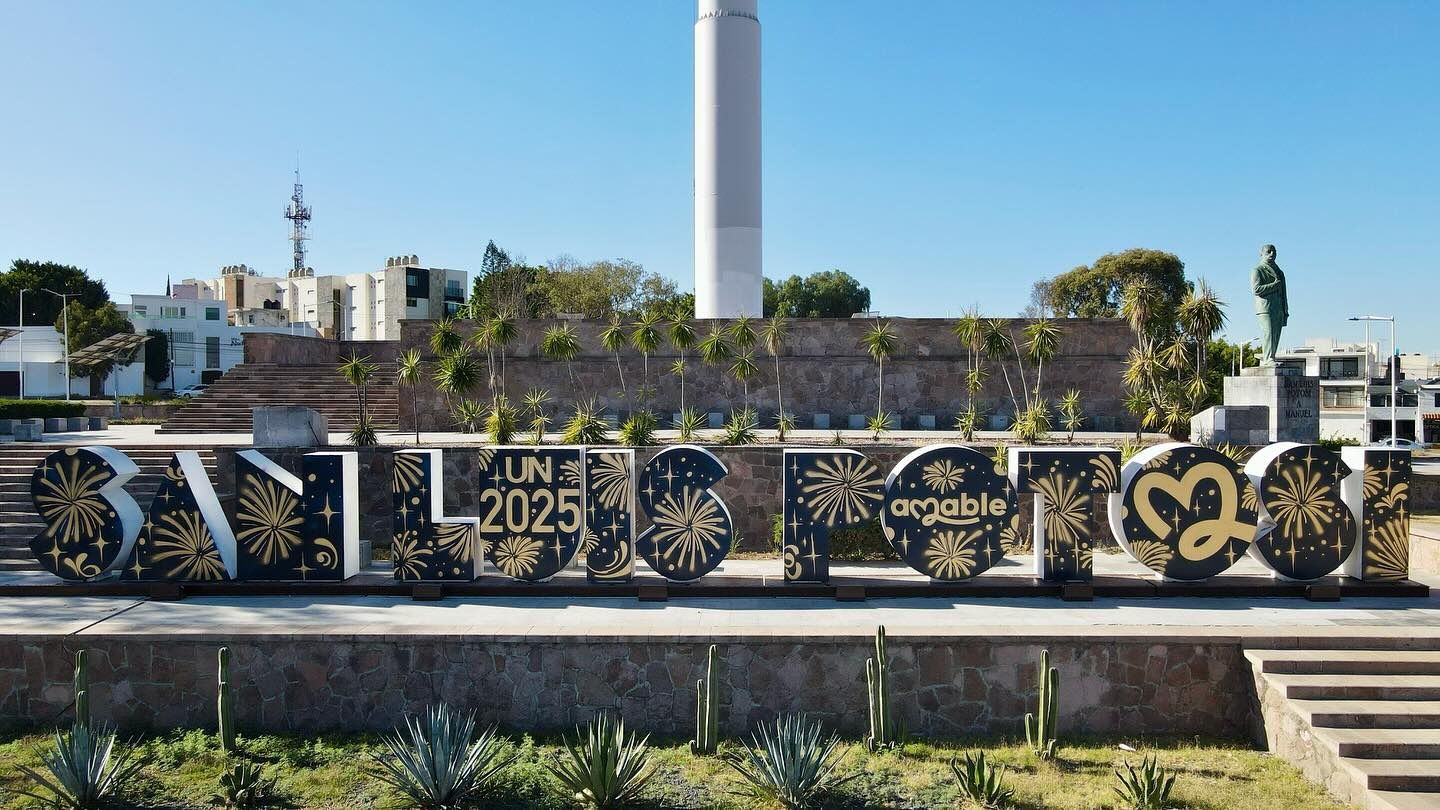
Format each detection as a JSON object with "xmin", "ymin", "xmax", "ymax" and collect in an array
[{"xmin": 0, "ymin": 731, "xmax": 1345, "ymax": 810}]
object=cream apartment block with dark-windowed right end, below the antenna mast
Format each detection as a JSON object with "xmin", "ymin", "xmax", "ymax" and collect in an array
[{"xmin": 173, "ymin": 255, "xmax": 468, "ymax": 340}]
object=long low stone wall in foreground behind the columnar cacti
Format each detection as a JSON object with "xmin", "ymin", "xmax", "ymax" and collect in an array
[{"xmin": 0, "ymin": 631, "xmax": 1254, "ymax": 736}]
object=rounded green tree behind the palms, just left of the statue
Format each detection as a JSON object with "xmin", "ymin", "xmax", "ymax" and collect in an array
[{"xmin": 1047, "ymin": 248, "xmax": 1189, "ymax": 330}]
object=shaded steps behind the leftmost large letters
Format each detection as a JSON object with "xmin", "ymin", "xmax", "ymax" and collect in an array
[{"xmin": 0, "ymin": 444, "xmax": 216, "ymax": 571}]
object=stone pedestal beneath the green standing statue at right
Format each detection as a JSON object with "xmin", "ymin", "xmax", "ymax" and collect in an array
[{"xmin": 1214, "ymin": 366, "xmax": 1320, "ymax": 444}]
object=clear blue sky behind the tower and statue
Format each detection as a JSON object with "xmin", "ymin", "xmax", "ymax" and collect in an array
[{"xmin": 0, "ymin": 0, "xmax": 1440, "ymax": 352}]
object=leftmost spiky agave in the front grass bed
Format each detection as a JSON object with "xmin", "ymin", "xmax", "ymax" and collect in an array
[{"xmin": 14, "ymin": 722, "xmax": 144, "ymax": 810}]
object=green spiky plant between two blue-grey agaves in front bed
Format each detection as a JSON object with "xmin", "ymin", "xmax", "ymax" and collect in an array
[{"xmin": 554, "ymin": 713, "xmax": 655, "ymax": 810}]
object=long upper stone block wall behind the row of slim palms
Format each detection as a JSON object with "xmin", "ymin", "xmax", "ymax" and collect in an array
[{"xmin": 348, "ymin": 319, "xmax": 1133, "ymax": 431}]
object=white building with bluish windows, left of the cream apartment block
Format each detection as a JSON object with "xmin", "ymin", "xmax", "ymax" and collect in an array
[{"xmin": 118, "ymin": 292, "xmax": 315, "ymax": 391}]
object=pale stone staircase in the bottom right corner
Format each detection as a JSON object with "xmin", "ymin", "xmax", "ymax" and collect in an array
[{"xmin": 1246, "ymin": 638, "xmax": 1440, "ymax": 810}]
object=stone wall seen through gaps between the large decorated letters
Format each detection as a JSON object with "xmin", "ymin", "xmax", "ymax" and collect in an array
[{"xmin": 215, "ymin": 444, "xmax": 1115, "ymax": 551}]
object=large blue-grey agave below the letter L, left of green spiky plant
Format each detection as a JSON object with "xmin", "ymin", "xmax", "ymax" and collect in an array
[{"xmin": 370, "ymin": 703, "xmax": 516, "ymax": 810}]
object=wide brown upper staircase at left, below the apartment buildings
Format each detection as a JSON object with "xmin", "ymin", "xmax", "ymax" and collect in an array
[{"xmin": 157, "ymin": 363, "xmax": 400, "ymax": 434}]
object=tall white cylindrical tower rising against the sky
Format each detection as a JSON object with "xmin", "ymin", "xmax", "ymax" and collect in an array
[{"xmin": 696, "ymin": 0, "xmax": 763, "ymax": 319}]
